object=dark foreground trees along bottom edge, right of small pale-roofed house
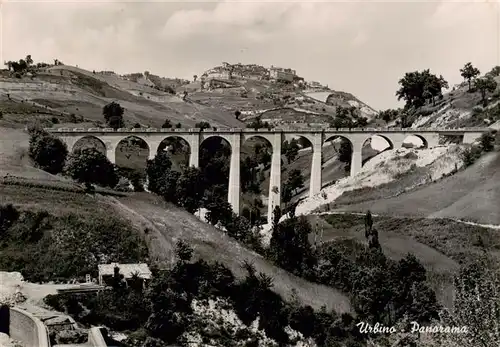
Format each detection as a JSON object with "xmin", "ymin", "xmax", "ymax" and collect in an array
[{"xmin": 45, "ymin": 241, "xmax": 366, "ymax": 347}]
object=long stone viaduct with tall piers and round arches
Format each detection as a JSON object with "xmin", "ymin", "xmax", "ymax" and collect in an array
[{"xmin": 46, "ymin": 128, "xmax": 489, "ymax": 220}]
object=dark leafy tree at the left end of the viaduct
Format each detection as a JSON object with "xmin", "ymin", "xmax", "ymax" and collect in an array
[{"xmin": 29, "ymin": 128, "xmax": 68, "ymax": 175}]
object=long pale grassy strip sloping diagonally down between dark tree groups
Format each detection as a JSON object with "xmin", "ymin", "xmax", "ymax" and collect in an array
[{"xmin": 104, "ymin": 194, "xmax": 352, "ymax": 312}]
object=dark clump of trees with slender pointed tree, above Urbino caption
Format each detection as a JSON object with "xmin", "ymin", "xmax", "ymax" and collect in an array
[{"xmin": 266, "ymin": 212, "xmax": 440, "ymax": 334}]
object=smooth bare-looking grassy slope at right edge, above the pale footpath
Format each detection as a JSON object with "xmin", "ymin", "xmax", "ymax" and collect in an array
[{"xmin": 336, "ymin": 152, "xmax": 500, "ymax": 224}]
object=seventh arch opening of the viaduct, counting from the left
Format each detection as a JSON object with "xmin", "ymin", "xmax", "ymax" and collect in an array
[{"xmin": 321, "ymin": 134, "xmax": 354, "ymax": 187}]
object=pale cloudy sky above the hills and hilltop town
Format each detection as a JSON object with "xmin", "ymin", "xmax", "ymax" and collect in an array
[{"xmin": 0, "ymin": 0, "xmax": 500, "ymax": 109}]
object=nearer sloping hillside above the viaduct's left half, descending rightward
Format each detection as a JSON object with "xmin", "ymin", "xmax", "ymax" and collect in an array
[{"xmin": 0, "ymin": 65, "xmax": 241, "ymax": 127}]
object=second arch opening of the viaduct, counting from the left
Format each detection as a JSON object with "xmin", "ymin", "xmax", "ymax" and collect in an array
[{"xmin": 114, "ymin": 135, "xmax": 151, "ymax": 170}]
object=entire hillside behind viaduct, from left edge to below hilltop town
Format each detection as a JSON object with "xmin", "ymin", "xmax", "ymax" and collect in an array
[{"xmin": 0, "ymin": 60, "xmax": 375, "ymax": 133}]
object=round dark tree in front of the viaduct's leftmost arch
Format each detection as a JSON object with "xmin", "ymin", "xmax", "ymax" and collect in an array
[{"xmin": 65, "ymin": 148, "xmax": 118, "ymax": 191}]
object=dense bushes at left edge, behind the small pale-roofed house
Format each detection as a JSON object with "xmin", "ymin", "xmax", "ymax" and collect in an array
[{"xmin": 0, "ymin": 204, "xmax": 147, "ymax": 282}]
